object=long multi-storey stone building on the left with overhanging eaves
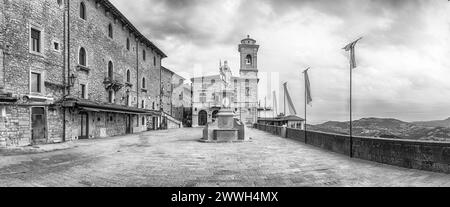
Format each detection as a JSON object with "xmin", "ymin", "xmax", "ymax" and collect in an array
[{"xmin": 0, "ymin": 0, "xmax": 167, "ymax": 147}]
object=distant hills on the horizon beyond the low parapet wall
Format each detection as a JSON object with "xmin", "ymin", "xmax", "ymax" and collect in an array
[{"xmin": 308, "ymin": 118, "xmax": 450, "ymax": 141}]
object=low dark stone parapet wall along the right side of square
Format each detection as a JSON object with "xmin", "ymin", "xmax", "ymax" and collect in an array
[{"xmin": 255, "ymin": 124, "xmax": 450, "ymax": 173}]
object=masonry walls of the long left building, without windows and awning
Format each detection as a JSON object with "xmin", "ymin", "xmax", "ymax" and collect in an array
[{"xmin": 0, "ymin": 0, "xmax": 163, "ymax": 146}]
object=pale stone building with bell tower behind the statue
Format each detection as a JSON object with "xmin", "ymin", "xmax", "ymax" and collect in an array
[{"xmin": 191, "ymin": 36, "xmax": 259, "ymax": 127}]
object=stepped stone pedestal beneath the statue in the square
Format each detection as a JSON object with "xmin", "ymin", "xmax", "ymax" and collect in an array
[{"xmin": 200, "ymin": 109, "xmax": 249, "ymax": 143}]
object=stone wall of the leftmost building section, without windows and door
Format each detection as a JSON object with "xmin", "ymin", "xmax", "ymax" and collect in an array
[{"xmin": 0, "ymin": 0, "xmax": 64, "ymax": 146}]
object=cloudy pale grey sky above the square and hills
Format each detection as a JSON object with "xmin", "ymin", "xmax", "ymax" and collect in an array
[{"xmin": 111, "ymin": 0, "xmax": 450, "ymax": 123}]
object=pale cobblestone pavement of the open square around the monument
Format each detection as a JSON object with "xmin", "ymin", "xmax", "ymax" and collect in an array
[{"xmin": 0, "ymin": 128, "xmax": 450, "ymax": 187}]
